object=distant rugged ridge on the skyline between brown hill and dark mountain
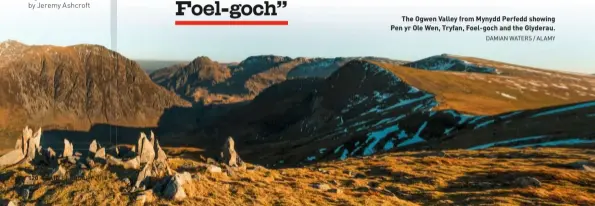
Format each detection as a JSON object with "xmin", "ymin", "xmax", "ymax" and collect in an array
[{"xmin": 151, "ymin": 55, "xmax": 403, "ymax": 104}]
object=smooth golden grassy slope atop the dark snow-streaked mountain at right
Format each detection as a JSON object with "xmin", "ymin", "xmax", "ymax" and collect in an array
[{"xmin": 370, "ymin": 61, "xmax": 595, "ymax": 115}]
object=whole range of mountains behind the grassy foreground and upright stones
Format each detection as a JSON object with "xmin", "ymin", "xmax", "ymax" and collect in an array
[{"xmin": 0, "ymin": 41, "xmax": 595, "ymax": 166}]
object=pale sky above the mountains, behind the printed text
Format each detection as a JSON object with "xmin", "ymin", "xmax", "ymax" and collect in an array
[{"xmin": 0, "ymin": 0, "xmax": 595, "ymax": 73}]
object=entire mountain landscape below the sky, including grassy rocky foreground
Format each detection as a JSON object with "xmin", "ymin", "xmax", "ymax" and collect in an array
[{"xmin": 0, "ymin": 40, "xmax": 595, "ymax": 205}]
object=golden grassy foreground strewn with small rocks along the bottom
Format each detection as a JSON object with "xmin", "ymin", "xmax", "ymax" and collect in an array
[{"xmin": 0, "ymin": 148, "xmax": 595, "ymax": 205}]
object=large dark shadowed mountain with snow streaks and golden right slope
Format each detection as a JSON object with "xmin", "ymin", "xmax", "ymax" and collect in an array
[{"xmin": 190, "ymin": 57, "xmax": 595, "ymax": 166}]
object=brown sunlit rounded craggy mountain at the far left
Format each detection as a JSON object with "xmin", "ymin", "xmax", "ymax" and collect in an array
[{"xmin": 0, "ymin": 41, "xmax": 190, "ymax": 151}]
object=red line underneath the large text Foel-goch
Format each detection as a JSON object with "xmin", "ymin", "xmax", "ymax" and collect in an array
[{"xmin": 176, "ymin": 20, "xmax": 289, "ymax": 26}]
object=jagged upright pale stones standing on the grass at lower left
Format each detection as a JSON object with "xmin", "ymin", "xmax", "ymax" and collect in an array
[{"xmin": 0, "ymin": 127, "xmax": 245, "ymax": 200}]
